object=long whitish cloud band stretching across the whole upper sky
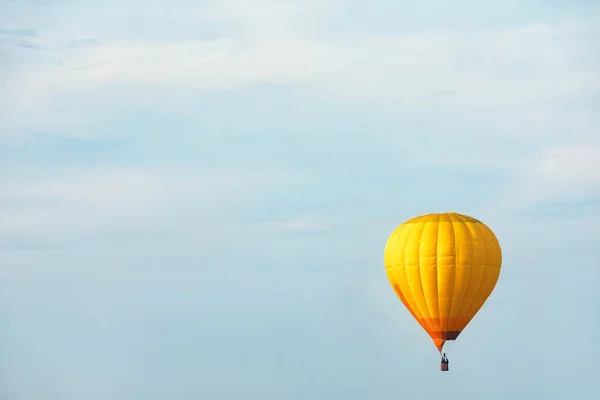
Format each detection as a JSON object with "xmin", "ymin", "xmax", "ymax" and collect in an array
[{"xmin": 10, "ymin": 20, "xmax": 600, "ymax": 103}]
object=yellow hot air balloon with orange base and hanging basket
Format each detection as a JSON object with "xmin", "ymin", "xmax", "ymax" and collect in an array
[{"xmin": 384, "ymin": 212, "xmax": 502, "ymax": 371}]
